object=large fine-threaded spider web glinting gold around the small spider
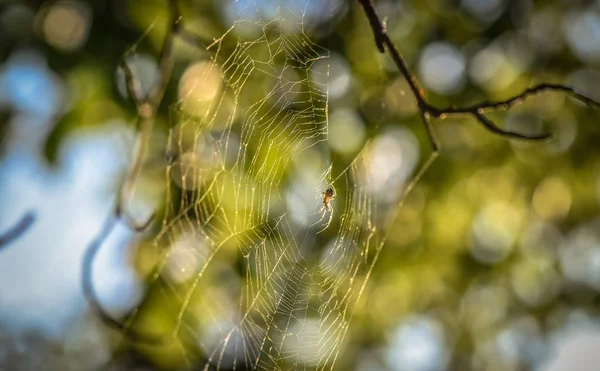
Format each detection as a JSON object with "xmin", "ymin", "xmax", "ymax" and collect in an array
[{"xmin": 115, "ymin": 0, "xmax": 418, "ymax": 370}]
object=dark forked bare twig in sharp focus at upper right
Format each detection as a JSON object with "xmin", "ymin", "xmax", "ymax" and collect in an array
[{"xmin": 358, "ymin": 0, "xmax": 600, "ymax": 148}]
